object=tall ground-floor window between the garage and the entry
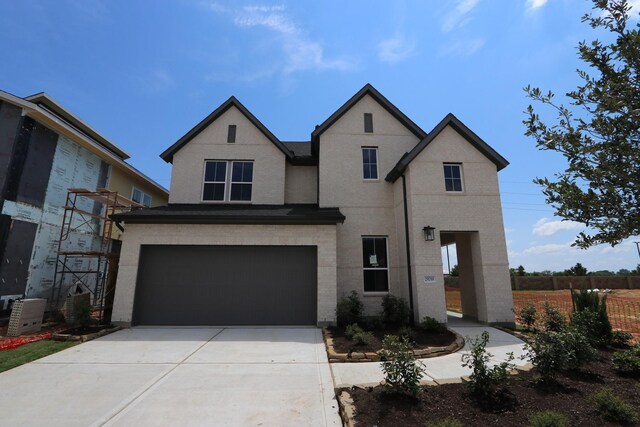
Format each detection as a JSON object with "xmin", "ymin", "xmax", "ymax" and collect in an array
[{"xmin": 362, "ymin": 236, "xmax": 389, "ymax": 292}]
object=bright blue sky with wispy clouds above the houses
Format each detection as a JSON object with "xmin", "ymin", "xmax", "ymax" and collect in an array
[{"xmin": 0, "ymin": 0, "xmax": 640, "ymax": 270}]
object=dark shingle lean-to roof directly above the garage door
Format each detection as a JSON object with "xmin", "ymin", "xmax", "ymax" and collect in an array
[{"xmin": 111, "ymin": 203, "xmax": 345, "ymax": 224}]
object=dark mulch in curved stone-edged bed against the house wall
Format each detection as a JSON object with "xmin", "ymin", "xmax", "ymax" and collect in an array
[{"xmin": 329, "ymin": 327, "xmax": 456, "ymax": 353}]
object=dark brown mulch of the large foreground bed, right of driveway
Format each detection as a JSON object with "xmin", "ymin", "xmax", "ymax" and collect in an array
[{"xmin": 338, "ymin": 351, "xmax": 640, "ymax": 427}]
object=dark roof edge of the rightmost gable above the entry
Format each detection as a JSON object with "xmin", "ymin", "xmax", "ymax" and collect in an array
[{"xmin": 385, "ymin": 113, "xmax": 509, "ymax": 182}]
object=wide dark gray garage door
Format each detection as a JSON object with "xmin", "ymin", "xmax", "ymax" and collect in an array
[{"xmin": 132, "ymin": 245, "xmax": 317, "ymax": 325}]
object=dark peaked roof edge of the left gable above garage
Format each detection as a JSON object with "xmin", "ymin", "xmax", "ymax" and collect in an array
[{"xmin": 160, "ymin": 96, "xmax": 293, "ymax": 163}]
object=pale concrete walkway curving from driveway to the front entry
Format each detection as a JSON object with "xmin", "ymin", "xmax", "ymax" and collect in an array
[{"xmin": 331, "ymin": 312, "xmax": 527, "ymax": 387}]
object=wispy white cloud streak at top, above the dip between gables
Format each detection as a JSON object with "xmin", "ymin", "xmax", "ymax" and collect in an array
[{"xmin": 205, "ymin": 3, "xmax": 355, "ymax": 74}]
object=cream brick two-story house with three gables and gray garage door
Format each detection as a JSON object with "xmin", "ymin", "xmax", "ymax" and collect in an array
[{"xmin": 113, "ymin": 84, "xmax": 513, "ymax": 325}]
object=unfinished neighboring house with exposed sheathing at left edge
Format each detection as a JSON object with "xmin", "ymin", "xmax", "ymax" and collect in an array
[{"xmin": 0, "ymin": 91, "xmax": 168, "ymax": 313}]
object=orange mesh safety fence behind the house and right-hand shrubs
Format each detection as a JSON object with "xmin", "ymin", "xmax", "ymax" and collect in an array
[{"xmin": 445, "ymin": 287, "xmax": 640, "ymax": 336}]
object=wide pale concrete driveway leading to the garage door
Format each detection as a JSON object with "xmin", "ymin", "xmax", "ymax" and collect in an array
[{"xmin": 0, "ymin": 327, "xmax": 342, "ymax": 427}]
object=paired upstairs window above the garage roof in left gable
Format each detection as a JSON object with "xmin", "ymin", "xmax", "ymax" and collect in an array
[{"xmin": 202, "ymin": 160, "xmax": 253, "ymax": 202}]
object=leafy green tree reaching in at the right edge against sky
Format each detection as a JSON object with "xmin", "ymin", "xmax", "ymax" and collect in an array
[{"xmin": 523, "ymin": 0, "xmax": 640, "ymax": 248}]
